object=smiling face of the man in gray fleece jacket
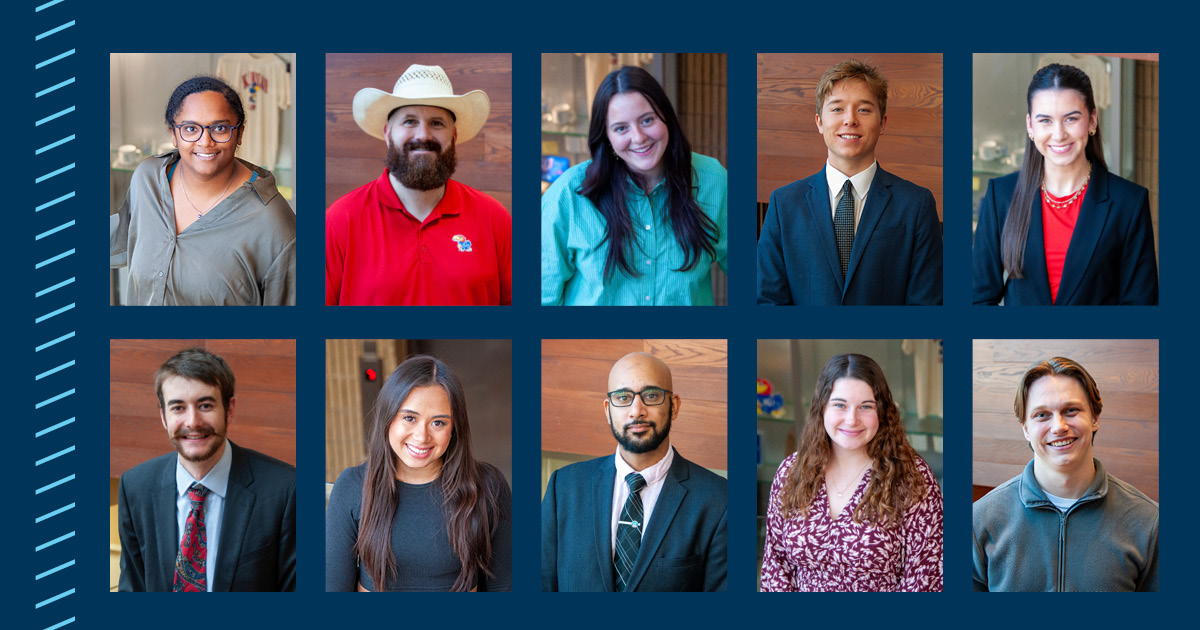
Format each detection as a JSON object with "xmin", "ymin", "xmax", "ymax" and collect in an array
[{"xmin": 1021, "ymin": 374, "xmax": 1100, "ymax": 473}]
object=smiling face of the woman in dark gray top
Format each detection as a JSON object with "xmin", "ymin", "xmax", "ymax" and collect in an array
[{"xmin": 388, "ymin": 385, "xmax": 454, "ymax": 484}]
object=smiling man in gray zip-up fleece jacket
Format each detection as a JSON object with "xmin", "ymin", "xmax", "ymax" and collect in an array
[{"xmin": 972, "ymin": 356, "xmax": 1158, "ymax": 592}]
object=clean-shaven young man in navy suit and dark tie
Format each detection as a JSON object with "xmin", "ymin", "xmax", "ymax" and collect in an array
[{"xmin": 758, "ymin": 59, "xmax": 942, "ymax": 306}]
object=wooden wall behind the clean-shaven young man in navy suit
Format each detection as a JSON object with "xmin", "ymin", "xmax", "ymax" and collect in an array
[{"xmin": 757, "ymin": 53, "xmax": 943, "ymax": 216}]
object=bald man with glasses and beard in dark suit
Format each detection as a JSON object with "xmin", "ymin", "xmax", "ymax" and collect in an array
[{"xmin": 541, "ymin": 353, "xmax": 727, "ymax": 592}]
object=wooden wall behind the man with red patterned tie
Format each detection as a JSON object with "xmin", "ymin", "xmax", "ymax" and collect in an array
[{"xmin": 108, "ymin": 340, "xmax": 296, "ymax": 476}]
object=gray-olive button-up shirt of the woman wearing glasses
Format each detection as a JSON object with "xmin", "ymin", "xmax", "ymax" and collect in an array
[{"xmin": 108, "ymin": 151, "xmax": 296, "ymax": 306}]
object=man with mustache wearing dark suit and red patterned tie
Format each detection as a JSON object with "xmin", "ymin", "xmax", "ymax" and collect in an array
[{"xmin": 118, "ymin": 348, "xmax": 296, "ymax": 592}]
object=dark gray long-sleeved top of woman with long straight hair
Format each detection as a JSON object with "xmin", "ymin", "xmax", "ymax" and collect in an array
[{"xmin": 325, "ymin": 463, "xmax": 512, "ymax": 592}]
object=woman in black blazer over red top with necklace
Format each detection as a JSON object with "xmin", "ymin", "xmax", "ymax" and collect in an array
[{"xmin": 973, "ymin": 64, "xmax": 1158, "ymax": 306}]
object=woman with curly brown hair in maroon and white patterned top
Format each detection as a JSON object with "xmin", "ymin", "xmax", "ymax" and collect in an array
[{"xmin": 762, "ymin": 354, "xmax": 942, "ymax": 592}]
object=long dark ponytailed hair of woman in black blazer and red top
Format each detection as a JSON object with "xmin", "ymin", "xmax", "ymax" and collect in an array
[{"xmin": 1000, "ymin": 64, "xmax": 1108, "ymax": 278}]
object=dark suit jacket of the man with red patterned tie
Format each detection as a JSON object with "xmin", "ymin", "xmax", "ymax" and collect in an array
[{"xmin": 116, "ymin": 442, "xmax": 296, "ymax": 592}]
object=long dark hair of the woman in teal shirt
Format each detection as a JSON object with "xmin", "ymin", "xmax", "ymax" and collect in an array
[{"xmin": 576, "ymin": 66, "xmax": 720, "ymax": 281}]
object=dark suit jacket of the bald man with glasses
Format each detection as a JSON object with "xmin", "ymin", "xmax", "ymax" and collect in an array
[{"xmin": 541, "ymin": 451, "xmax": 728, "ymax": 592}]
